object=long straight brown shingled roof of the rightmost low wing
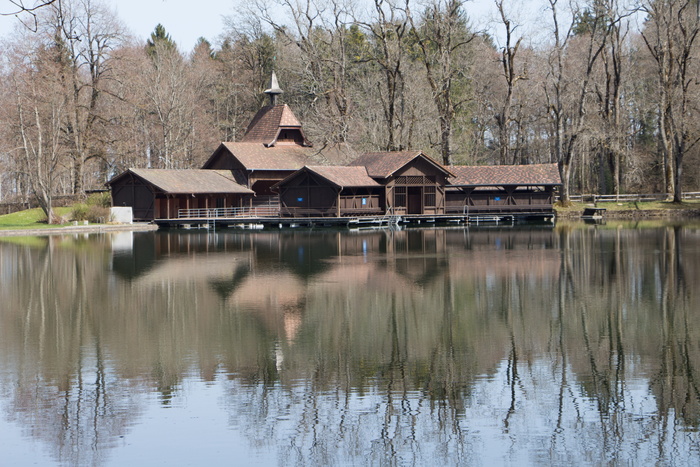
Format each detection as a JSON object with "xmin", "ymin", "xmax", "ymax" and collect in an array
[{"xmin": 450, "ymin": 164, "xmax": 561, "ymax": 186}]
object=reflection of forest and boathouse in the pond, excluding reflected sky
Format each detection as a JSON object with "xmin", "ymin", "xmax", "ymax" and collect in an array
[{"xmin": 0, "ymin": 226, "xmax": 700, "ymax": 463}]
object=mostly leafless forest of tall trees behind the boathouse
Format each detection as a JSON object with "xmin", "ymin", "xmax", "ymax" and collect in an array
[{"xmin": 0, "ymin": 0, "xmax": 700, "ymax": 220}]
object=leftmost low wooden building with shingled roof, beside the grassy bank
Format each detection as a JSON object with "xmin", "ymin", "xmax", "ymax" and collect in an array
[{"xmin": 107, "ymin": 169, "xmax": 254, "ymax": 221}]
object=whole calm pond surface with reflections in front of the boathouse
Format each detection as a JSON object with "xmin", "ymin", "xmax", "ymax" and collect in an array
[{"xmin": 0, "ymin": 224, "xmax": 700, "ymax": 466}]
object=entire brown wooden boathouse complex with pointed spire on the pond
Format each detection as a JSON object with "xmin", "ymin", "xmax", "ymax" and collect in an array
[{"xmin": 108, "ymin": 73, "xmax": 561, "ymax": 227}]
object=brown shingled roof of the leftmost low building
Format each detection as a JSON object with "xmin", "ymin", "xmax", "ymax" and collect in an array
[{"xmin": 108, "ymin": 169, "xmax": 254, "ymax": 194}]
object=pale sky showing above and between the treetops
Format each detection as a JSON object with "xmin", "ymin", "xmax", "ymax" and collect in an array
[{"xmin": 0, "ymin": 0, "xmax": 545, "ymax": 52}]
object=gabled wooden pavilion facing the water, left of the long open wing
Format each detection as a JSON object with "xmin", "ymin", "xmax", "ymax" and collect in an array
[{"xmin": 352, "ymin": 151, "xmax": 452, "ymax": 215}]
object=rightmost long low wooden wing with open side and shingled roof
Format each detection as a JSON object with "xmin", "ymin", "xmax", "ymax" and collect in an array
[{"xmin": 446, "ymin": 164, "xmax": 561, "ymax": 214}]
